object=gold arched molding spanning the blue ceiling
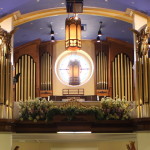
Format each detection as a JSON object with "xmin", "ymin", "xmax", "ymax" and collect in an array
[{"xmin": 14, "ymin": 7, "xmax": 132, "ymax": 26}]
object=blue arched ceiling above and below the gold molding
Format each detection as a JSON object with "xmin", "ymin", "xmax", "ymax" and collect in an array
[{"xmin": 0, "ymin": 0, "xmax": 150, "ymax": 46}]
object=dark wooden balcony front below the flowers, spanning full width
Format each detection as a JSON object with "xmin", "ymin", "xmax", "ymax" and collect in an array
[{"xmin": 0, "ymin": 118, "xmax": 150, "ymax": 133}]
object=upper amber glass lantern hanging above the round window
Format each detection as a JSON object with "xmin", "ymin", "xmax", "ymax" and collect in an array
[{"xmin": 65, "ymin": 17, "xmax": 81, "ymax": 51}]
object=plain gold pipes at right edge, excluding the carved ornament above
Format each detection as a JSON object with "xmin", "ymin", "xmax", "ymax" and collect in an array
[{"xmin": 138, "ymin": 55, "xmax": 150, "ymax": 117}]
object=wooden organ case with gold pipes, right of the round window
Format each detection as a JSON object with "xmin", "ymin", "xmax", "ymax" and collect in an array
[{"xmin": 95, "ymin": 38, "xmax": 133, "ymax": 98}]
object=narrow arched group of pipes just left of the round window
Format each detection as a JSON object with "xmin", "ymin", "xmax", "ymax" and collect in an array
[{"xmin": 40, "ymin": 52, "xmax": 52, "ymax": 91}]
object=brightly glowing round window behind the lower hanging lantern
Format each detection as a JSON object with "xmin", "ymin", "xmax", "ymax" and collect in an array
[{"xmin": 55, "ymin": 50, "xmax": 94, "ymax": 86}]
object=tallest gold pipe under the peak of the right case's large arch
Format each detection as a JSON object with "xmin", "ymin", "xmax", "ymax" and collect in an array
[{"xmin": 121, "ymin": 53, "xmax": 124, "ymax": 99}]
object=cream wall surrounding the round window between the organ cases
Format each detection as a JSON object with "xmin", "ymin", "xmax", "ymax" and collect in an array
[{"xmin": 53, "ymin": 40, "xmax": 95, "ymax": 95}]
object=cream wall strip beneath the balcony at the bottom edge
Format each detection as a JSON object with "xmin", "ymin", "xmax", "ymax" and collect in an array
[{"xmin": 13, "ymin": 139, "xmax": 132, "ymax": 150}]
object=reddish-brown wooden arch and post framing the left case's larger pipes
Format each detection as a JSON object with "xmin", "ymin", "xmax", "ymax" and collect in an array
[{"xmin": 14, "ymin": 39, "xmax": 41, "ymax": 97}]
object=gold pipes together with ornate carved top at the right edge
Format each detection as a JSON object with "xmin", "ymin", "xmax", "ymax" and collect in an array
[{"xmin": 133, "ymin": 26, "xmax": 150, "ymax": 117}]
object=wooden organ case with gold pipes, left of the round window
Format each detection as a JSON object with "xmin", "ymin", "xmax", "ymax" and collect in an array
[{"xmin": 14, "ymin": 40, "xmax": 52, "ymax": 101}]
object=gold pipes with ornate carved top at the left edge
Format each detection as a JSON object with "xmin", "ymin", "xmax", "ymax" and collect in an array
[{"xmin": 0, "ymin": 27, "xmax": 14, "ymax": 119}]
